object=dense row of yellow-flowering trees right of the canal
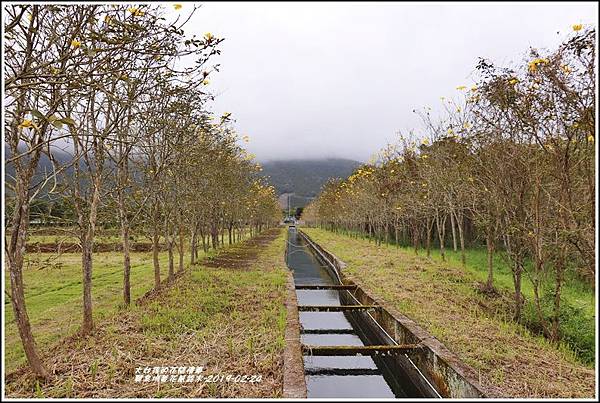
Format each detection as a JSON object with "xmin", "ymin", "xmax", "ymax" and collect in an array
[{"xmin": 304, "ymin": 25, "xmax": 596, "ymax": 340}]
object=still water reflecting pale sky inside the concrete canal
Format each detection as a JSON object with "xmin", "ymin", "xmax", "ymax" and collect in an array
[{"xmin": 286, "ymin": 227, "xmax": 432, "ymax": 398}]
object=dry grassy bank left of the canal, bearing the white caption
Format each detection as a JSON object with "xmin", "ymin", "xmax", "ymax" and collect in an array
[{"xmin": 6, "ymin": 229, "xmax": 286, "ymax": 398}]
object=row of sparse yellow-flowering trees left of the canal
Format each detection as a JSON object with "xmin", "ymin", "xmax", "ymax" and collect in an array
[{"xmin": 4, "ymin": 4, "xmax": 278, "ymax": 378}]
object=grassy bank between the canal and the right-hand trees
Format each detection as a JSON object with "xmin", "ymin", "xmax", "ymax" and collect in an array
[{"xmin": 305, "ymin": 228, "xmax": 595, "ymax": 397}]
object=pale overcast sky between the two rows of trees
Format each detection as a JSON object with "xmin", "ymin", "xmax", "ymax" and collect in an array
[{"xmin": 173, "ymin": 2, "xmax": 598, "ymax": 161}]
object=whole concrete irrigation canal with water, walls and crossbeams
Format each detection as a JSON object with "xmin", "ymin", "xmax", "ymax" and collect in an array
[{"xmin": 284, "ymin": 226, "xmax": 486, "ymax": 398}]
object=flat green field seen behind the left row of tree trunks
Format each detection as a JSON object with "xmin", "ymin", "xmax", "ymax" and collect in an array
[{"xmin": 4, "ymin": 229, "xmax": 253, "ymax": 372}]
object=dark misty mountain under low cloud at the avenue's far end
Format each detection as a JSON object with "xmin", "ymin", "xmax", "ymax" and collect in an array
[{"xmin": 262, "ymin": 158, "xmax": 361, "ymax": 198}]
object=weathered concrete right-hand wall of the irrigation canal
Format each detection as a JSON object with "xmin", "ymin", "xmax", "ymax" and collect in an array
[{"xmin": 299, "ymin": 231, "xmax": 500, "ymax": 398}]
